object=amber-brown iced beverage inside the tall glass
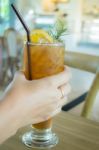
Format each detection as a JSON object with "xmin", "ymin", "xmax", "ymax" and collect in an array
[{"xmin": 23, "ymin": 43, "xmax": 64, "ymax": 129}]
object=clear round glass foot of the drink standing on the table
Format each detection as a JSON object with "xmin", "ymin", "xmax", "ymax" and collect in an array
[{"xmin": 22, "ymin": 129, "xmax": 59, "ymax": 149}]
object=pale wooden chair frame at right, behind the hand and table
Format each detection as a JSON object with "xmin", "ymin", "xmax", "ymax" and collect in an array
[{"xmin": 65, "ymin": 51, "xmax": 99, "ymax": 118}]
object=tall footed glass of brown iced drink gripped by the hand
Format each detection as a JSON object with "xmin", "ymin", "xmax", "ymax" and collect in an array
[{"xmin": 22, "ymin": 43, "xmax": 64, "ymax": 148}]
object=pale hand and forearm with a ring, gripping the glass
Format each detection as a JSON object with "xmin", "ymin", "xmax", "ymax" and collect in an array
[{"xmin": 0, "ymin": 67, "xmax": 71, "ymax": 144}]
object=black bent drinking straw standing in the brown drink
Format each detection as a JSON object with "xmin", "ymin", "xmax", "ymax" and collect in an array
[{"xmin": 11, "ymin": 4, "xmax": 32, "ymax": 80}]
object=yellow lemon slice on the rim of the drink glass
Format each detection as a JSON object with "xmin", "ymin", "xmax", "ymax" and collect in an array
[{"xmin": 30, "ymin": 29, "xmax": 53, "ymax": 43}]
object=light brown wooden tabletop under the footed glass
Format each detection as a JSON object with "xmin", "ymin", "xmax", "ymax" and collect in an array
[{"xmin": 0, "ymin": 112, "xmax": 99, "ymax": 150}]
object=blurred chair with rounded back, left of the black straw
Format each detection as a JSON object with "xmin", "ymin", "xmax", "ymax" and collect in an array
[{"xmin": 4, "ymin": 28, "xmax": 22, "ymax": 84}]
